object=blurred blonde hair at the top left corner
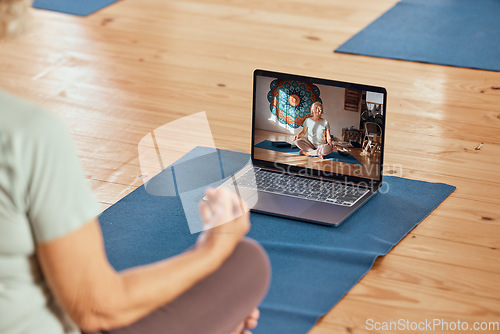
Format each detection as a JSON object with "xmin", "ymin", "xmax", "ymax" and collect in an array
[{"xmin": 0, "ymin": 0, "xmax": 33, "ymax": 38}]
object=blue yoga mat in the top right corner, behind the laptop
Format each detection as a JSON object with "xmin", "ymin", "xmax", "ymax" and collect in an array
[{"xmin": 335, "ymin": 0, "xmax": 500, "ymax": 71}]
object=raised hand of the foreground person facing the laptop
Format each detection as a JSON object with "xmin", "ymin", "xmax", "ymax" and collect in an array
[{"xmin": 196, "ymin": 188, "xmax": 250, "ymax": 259}]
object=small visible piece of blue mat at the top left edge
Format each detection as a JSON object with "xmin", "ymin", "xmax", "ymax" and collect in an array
[{"xmin": 33, "ymin": 0, "xmax": 118, "ymax": 16}]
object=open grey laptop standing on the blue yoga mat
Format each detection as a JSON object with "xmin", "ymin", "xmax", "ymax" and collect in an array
[{"xmin": 226, "ymin": 70, "xmax": 387, "ymax": 226}]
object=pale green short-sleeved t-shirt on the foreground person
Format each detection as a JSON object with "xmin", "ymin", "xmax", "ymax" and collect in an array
[{"xmin": 0, "ymin": 91, "xmax": 99, "ymax": 334}]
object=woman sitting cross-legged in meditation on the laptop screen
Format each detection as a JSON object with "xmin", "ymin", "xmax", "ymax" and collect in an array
[{"xmin": 293, "ymin": 102, "xmax": 333, "ymax": 159}]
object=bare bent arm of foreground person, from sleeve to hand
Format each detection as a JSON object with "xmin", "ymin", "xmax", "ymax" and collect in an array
[{"xmin": 37, "ymin": 190, "xmax": 249, "ymax": 331}]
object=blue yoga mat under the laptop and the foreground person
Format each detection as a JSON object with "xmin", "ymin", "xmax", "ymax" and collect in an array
[{"xmin": 99, "ymin": 147, "xmax": 455, "ymax": 334}]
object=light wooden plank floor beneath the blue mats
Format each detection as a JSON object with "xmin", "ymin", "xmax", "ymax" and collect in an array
[{"xmin": 0, "ymin": 0, "xmax": 500, "ymax": 334}]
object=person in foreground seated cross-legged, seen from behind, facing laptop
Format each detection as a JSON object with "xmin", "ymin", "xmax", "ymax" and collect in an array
[{"xmin": 0, "ymin": 0, "xmax": 270, "ymax": 334}]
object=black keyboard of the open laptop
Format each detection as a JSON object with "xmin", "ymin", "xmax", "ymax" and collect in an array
[{"xmin": 231, "ymin": 168, "xmax": 368, "ymax": 206}]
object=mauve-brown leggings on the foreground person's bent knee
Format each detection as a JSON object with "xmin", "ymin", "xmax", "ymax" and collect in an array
[{"xmin": 88, "ymin": 239, "xmax": 271, "ymax": 334}]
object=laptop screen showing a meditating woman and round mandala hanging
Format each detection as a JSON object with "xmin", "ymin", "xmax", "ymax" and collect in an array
[{"xmin": 252, "ymin": 70, "xmax": 386, "ymax": 182}]
